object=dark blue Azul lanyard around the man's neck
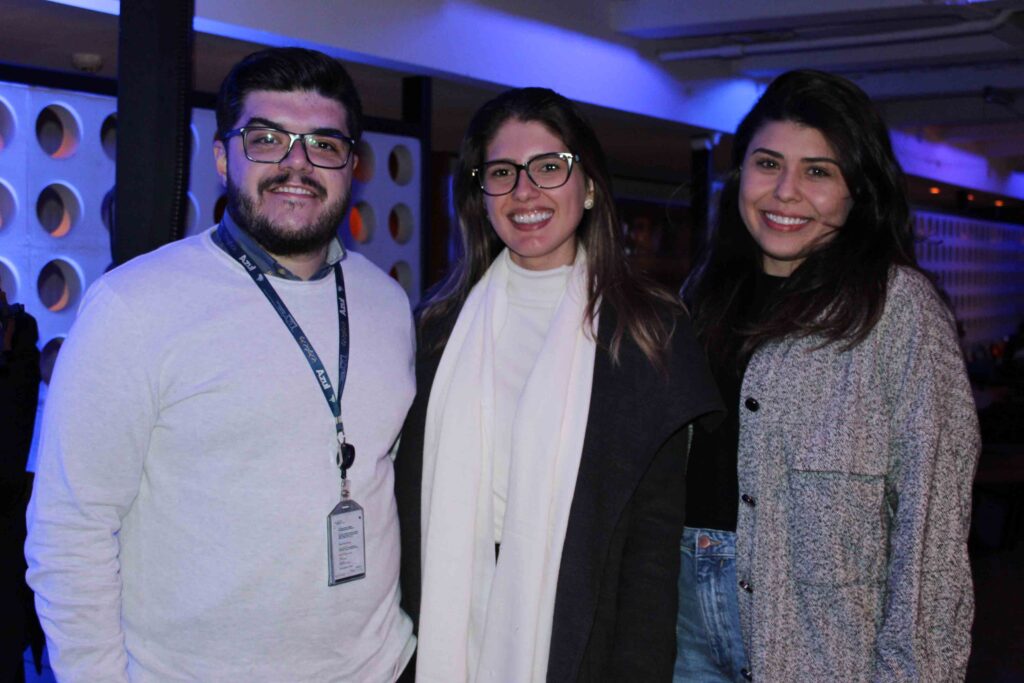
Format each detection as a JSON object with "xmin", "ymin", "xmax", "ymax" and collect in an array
[{"xmin": 217, "ymin": 225, "xmax": 354, "ymax": 454}]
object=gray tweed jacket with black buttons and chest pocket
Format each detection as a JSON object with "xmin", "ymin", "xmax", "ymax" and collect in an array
[{"xmin": 736, "ymin": 269, "xmax": 980, "ymax": 683}]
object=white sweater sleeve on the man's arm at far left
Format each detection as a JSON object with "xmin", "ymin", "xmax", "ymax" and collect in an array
[{"xmin": 26, "ymin": 281, "xmax": 156, "ymax": 683}]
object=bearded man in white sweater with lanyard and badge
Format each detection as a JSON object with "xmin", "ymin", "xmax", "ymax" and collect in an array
[{"xmin": 27, "ymin": 48, "xmax": 415, "ymax": 683}]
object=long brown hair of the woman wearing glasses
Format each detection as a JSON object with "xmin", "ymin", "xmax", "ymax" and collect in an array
[{"xmin": 420, "ymin": 88, "xmax": 679, "ymax": 368}]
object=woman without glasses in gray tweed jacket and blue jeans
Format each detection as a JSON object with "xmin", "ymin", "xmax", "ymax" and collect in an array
[{"xmin": 676, "ymin": 71, "xmax": 979, "ymax": 682}]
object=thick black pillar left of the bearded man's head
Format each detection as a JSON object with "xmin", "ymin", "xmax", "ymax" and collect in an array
[{"xmin": 111, "ymin": 0, "xmax": 195, "ymax": 264}]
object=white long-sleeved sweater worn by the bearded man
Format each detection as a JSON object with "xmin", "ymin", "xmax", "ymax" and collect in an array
[{"xmin": 27, "ymin": 230, "xmax": 415, "ymax": 683}]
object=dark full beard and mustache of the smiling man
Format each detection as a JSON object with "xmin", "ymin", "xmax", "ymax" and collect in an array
[{"xmin": 227, "ymin": 173, "xmax": 349, "ymax": 256}]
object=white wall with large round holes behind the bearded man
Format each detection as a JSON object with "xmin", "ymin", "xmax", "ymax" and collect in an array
[{"xmin": 0, "ymin": 82, "xmax": 422, "ymax": 374}]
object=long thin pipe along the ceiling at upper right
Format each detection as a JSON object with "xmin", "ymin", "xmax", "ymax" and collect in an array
[{"xmin": 657, "ymin": 9, "xmax": 1018, "ymax": 61}]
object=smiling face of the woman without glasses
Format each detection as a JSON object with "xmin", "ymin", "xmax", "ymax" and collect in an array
[{"xmin": 739, "ymin": 121, "xmax": 853, "ymax": 276}]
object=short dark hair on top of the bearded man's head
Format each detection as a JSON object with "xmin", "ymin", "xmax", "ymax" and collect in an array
[{"xmin": 211, "ymin": 47, "xmax": 362, "ymax": 140}]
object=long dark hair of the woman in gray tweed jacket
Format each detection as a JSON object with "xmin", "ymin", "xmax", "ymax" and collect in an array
[{"xmin": 683, "ymin": 70, "xmax": 921, "ymax": 360}]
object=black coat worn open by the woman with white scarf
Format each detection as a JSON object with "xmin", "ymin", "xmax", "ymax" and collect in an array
[{"xmin": 395, "ymin": 306, "xmax": 721, "ymax": 682}]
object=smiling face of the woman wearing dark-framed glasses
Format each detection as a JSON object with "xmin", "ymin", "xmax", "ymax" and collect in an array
[{"xmin": 484, "ymin": 119, "xmax": 594, "ymax": 270}]
